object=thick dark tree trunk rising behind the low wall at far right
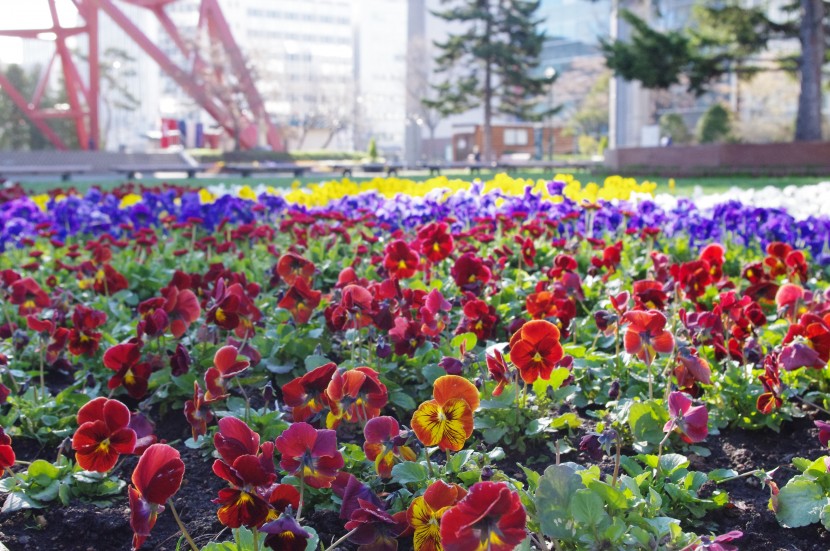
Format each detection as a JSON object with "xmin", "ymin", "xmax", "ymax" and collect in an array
[{"xmin": 795, "ymin": 0, "xmax": 825, "ymax": 141}]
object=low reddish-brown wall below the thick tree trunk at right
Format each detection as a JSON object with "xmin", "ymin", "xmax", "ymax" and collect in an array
[{"xmin": 605, "ymin": 142, "xmax": 830, "ymax": 176}]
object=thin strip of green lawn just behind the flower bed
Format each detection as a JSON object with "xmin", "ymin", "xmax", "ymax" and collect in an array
[{"xmin": 14, "ymin": 170, "xmax": 830, "ymax": 195}]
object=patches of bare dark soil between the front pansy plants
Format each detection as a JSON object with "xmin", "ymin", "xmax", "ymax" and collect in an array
[{"xmin": 0, "ymin": 412, "xmax": 830, "ymax": 551}]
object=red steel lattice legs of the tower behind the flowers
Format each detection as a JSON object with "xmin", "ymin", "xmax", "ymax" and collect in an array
[{"xmin": 0, "ymin": 0, "xmax": 285, "ymax": 151}]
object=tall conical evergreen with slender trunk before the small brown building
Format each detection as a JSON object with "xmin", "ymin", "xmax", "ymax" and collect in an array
[{"xmin": 423, "ymin": 0, "xmax": 550, "ymax": 161}]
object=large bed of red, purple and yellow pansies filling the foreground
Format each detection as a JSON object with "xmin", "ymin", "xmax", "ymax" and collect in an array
[{"xmin": 0, "ymin": 175, "xmax": 830, "ymax": 551}]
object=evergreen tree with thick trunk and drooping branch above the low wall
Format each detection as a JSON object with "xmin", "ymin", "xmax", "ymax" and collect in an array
[{"xmin": 602, "ymin": 0, "xmax": 830, "ymax": 141}]
